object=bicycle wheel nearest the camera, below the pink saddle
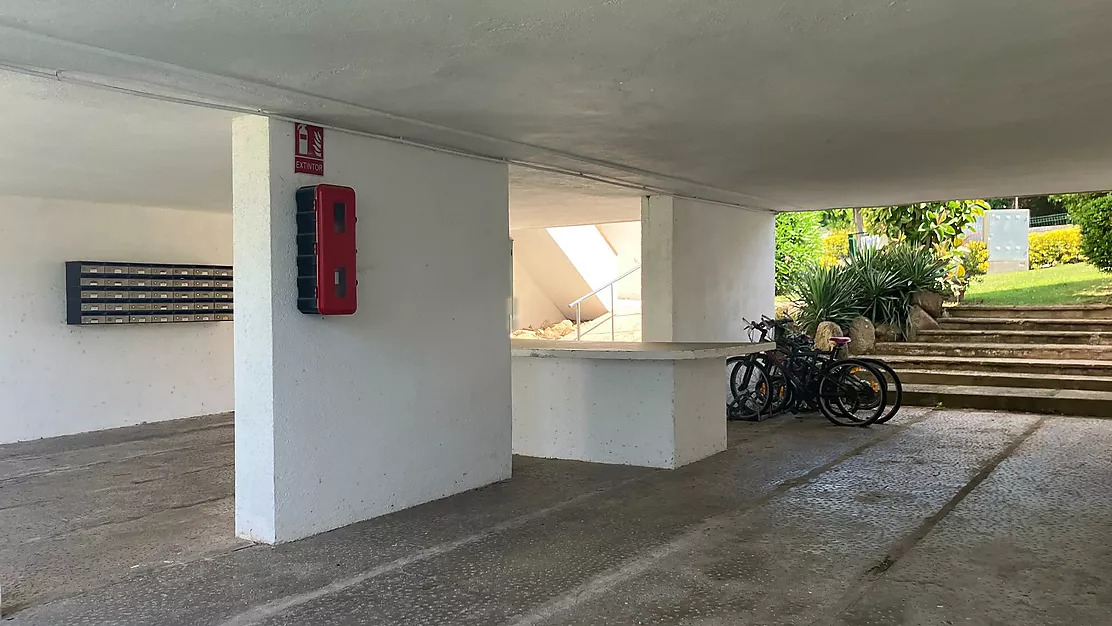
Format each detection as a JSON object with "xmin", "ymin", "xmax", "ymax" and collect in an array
[{"xmin": 818, "ymin": 359, "xmax": 887, "ymax": 426}]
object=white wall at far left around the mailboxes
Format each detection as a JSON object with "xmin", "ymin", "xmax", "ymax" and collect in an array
[{"xmin": 0, "ymin": 197, "xmax": 234, "ymax": 443}]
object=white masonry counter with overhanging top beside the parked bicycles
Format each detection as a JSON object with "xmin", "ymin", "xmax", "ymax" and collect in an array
[{"xmin": 510, "ymin": 340, "xmax": 774, "ymax": 468}]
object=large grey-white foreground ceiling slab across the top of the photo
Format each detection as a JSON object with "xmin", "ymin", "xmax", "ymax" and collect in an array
[{"xmin": 0, "ymin": 0, "xmax": 1112, "ymax": 209}]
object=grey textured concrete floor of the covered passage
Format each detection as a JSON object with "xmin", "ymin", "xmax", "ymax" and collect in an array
[{"xmin": 0, "ymin": 409, "xmax": 1112, "ymax": 626}]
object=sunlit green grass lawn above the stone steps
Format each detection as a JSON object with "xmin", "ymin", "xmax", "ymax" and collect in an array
[{"xmin": 964, "ymin": 264, "xmax": 1112, "ymax": 305}]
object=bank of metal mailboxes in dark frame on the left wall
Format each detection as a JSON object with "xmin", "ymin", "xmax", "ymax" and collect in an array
[{"xmin": 66, "ymin": 261, "xmax": 235, "ymax": 326}]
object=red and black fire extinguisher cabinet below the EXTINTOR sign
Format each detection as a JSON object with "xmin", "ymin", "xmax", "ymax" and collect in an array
[{"xmin": 297, "ymin": 185, "xmax": 357, "ymax": 315}]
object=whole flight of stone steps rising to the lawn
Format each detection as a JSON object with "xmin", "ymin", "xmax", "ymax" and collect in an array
[{"xmin": 876, "ymin": 305, "xmax": 1112, "ymax": 417}]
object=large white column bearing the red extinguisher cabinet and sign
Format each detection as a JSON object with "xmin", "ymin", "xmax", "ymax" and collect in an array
[{"xmin": 232, "ymin": 117, "xmax": 512, "ymax": 543}]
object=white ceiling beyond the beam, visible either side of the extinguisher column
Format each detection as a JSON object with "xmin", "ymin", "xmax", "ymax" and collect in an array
[{"xmin": 0, "ymin": 71, "xmax": 641, "ymax": 229}]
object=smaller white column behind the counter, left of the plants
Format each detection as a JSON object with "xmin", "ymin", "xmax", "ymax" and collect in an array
[{"xmin": 641, "ymin": 196, "xmax": 776, "ymax": 341}]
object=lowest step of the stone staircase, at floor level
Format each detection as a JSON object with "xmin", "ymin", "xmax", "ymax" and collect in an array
[{"xmin": 903, "ymin": 385, "xmax": 1112, "ymax": 417}]
